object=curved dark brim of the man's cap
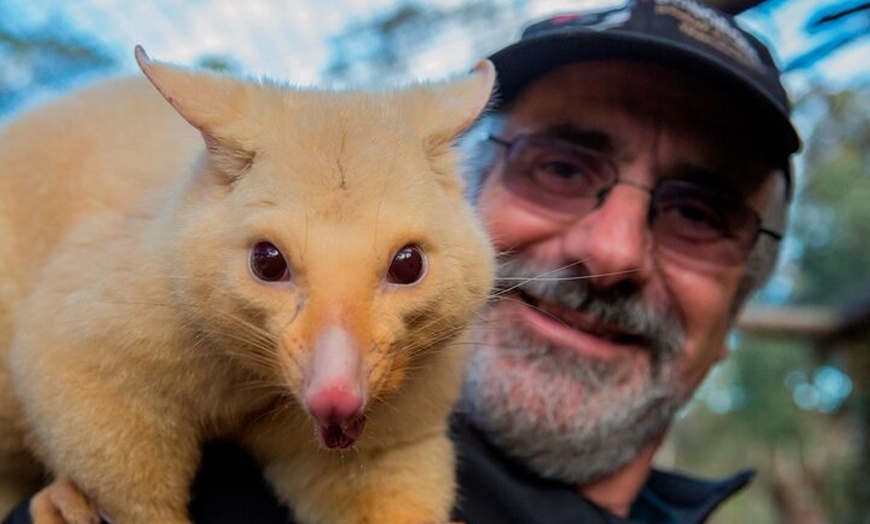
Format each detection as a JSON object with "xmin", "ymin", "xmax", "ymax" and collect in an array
[{"xmin": 489, "ymin": 29, "xmax": 800, "ymax": 155}]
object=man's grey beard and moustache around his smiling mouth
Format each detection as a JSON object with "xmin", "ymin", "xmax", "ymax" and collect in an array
[{"xmin": 459, "ymin": 263, "xmax": 689, "ymax": 484}]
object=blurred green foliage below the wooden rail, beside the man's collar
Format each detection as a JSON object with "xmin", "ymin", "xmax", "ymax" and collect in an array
[{"xmin": 663, "ymin": 337, "xmax": 866, "ymax": 524}]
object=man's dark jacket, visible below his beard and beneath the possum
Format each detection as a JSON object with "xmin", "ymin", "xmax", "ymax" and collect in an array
[{"xmin": 4, "ymin": 416, "xmax": 752, "ymax": 524}]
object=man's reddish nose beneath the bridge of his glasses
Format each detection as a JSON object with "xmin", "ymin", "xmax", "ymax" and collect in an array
[{"xmin": 562, "ymin": 184, "xmax": 653, "ymax": 288}]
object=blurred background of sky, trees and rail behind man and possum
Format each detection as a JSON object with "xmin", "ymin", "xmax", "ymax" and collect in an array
[{"xmin": 0, "ymin": 0, "xmax": 870, "ymax": 524}]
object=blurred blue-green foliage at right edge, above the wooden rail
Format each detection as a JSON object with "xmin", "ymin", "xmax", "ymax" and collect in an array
[{"xmin": 791, "ymin": 88, "xmax": 870, "ymax": 306}]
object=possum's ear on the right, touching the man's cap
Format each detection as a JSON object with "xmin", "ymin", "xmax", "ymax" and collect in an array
[{"xmin": 422, "ymin": 60, "xmax": 496, "ymax": 142}]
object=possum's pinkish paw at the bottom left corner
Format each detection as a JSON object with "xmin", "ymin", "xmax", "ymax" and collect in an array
[{"xmin": 30, "ymin": 478, "xmax": 102, "ymax": 524}]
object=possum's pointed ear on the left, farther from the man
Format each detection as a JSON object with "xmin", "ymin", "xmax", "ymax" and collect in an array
[{"xmin": 135, "ymin": 46, "xmax": 254, "ymax": 179}]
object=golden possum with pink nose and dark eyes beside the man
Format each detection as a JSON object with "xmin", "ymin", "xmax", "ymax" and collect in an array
[{"xmin": 0, "ymin": 48, "xmax": 494, "ymax": 524}]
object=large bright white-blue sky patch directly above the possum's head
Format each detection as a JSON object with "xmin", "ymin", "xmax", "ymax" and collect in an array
[{"xmin": 11, "ymin": 0, "xmax": 476, "ymax": 83}]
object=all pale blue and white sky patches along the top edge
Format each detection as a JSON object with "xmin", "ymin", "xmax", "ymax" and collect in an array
[{"xmin": 4, "ymin": 0, "xmax": 870, "ymax": 90}]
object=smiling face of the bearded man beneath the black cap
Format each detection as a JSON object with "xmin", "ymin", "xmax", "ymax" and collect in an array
[{"xmin": 463, "ymin": 62, "xmax": 777, "ymax": 482}]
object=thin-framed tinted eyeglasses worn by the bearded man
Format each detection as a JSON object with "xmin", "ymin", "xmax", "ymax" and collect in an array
[{"xmin": 488, "ymin": 133, "xmax": 782, "ymax": 265}]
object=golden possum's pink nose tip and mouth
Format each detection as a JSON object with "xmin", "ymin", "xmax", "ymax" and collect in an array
[{"xmin": 305, "ymin": 388, "xmax": 365, "ymax": 449}]
